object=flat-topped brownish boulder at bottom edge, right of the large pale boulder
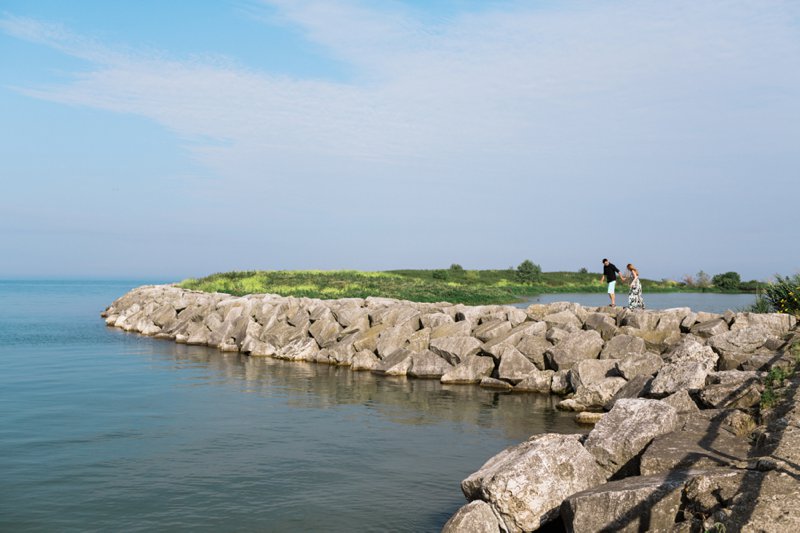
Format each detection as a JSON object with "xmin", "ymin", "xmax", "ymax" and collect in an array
[{"xmin": 561, "ymin": 475, "xmax": 686, "ymax": 533}]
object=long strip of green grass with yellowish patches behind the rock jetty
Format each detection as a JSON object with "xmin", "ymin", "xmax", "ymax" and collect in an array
[{"xmin": 179, "ymin": 269, "xmax": 720, "ymax": 305}]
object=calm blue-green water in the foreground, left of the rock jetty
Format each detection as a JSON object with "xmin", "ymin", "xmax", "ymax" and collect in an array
[{"xmin": 0, "ymin": 281, "xmax": 579, "ymax": 531}]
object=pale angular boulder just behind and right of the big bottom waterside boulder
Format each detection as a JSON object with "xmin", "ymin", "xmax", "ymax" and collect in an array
[{"xmin": 584, "ymin": 399, "xmax": 678, "ymax": 477}]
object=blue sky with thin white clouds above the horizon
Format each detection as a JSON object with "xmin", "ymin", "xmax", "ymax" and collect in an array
[{"xmin": 0, "ymin": 0, "xmax": 800, "ymax": 280}]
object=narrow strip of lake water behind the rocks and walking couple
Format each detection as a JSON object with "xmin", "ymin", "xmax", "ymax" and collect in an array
[{"xmin": 514, "ymin": 286, "xmax": 756, "ymax": 313}]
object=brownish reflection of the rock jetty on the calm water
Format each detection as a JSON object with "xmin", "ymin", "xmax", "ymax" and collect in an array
[{"xmin": 151, "ymin": 341, "xmax": 584, "ymax": 440}]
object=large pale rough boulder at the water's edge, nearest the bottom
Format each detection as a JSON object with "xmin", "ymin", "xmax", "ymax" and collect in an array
[{"xmin": 461, "ymin": 434, "xmax": 604, "ymax": 532}]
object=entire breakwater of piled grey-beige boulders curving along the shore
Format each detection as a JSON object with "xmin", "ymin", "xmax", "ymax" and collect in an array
[{"xmin": 103, "ymin": 285, "xmax": 800, "ymax": 531}]
